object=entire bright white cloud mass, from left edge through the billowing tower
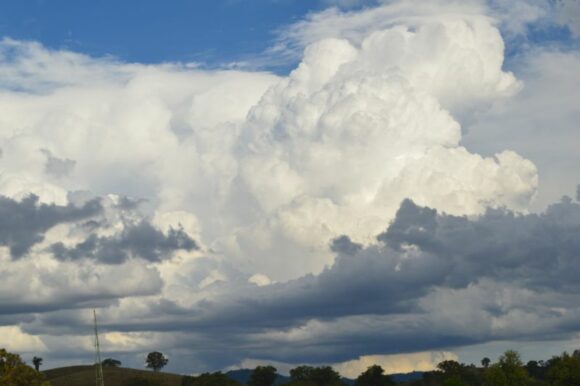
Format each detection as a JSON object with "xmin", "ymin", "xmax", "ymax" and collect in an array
[{"xmin": 0, "ymin": 6, "xmax": 537, "ymax": 280}]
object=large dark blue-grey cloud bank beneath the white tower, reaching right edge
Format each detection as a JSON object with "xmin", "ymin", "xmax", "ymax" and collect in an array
[{"xmin": 189, "ymin": 195, "xmax": 580, "ymax": 326}]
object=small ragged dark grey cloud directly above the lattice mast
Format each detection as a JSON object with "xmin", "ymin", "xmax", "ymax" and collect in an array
[{"xmin": 50, "ymin": 221, "xmax": 198, "ymax": 264}]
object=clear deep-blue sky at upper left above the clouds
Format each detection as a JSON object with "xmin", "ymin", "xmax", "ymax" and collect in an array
[{"xmin": 0, "ymin": 0, "xmax": 336, "ymax": 66}]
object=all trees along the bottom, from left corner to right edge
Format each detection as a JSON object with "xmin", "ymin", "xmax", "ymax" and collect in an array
[{"xmin": 0, "ymin": 348, "xmax": 580, "ymax": 386}]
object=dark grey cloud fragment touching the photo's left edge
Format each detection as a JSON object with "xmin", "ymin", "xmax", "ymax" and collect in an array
[{"xmin": 0, "ymin": 195, "xmax": 103, "ymax": 259}]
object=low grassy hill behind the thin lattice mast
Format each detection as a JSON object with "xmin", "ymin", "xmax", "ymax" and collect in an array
[{"xmin": 43, "ymin": 366, "xmax": 182, "ymax": 386}]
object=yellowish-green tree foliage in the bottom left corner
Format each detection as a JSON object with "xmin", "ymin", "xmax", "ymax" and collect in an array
[{"xmin": 0, "ymin": 348, "xmax": 50, "ymax": 386}]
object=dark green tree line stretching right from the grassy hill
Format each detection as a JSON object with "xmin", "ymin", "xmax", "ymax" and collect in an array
[{"xmin": 182, "ymin": 350, "xmax": 580, "ymax": 386}]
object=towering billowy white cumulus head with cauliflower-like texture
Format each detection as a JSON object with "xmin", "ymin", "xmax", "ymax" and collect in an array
[{"xmin": 230, "ymin": 9, "xmax": 537, "ymax": 278}]
